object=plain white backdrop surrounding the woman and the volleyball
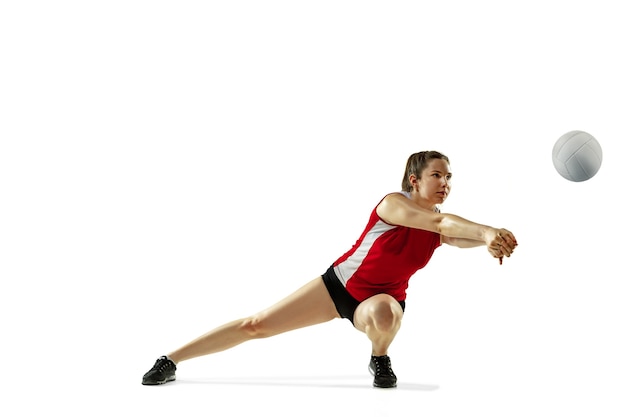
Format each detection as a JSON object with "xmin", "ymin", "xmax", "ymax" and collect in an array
[{"xmin": 0, "ymin": 0, "xmax": 626, "ymax": 417}]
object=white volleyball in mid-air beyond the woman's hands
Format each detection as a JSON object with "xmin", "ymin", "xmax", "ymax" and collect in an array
[{"xmin": 552, "ymin": 130, "xmax": 602, "ymax": 182}]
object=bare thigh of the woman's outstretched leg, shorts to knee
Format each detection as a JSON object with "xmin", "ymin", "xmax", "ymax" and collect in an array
[{"xmin": 250, "ymin": 277, "xmax": 339, "ymax": 337}]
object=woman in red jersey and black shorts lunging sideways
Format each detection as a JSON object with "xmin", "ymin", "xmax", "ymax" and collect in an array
[{"xmin": 142, "ymin": 151, "xmax": 517, "ymax": 388}]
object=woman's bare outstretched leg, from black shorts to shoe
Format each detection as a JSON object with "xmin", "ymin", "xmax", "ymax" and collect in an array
[{"xmin": 168, "ymin": 277, "xmax": 339, "ymax": 363}]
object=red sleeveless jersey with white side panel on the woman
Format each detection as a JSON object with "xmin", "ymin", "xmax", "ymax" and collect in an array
[{"xmin": 333, "ymin": 193, "xmax": 441, "ymax": 301}]
